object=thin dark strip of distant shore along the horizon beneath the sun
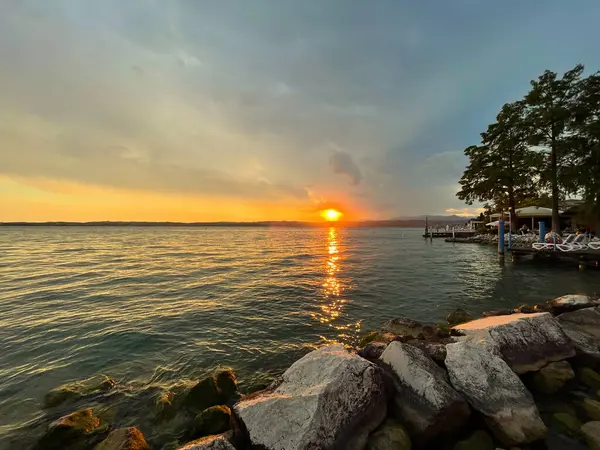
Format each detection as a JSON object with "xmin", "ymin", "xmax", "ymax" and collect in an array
[{"xmin": 0, "ymin": 220, "xmax": 432, "ymax": 228}]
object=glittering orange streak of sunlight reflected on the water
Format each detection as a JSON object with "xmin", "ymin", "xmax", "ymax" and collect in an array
[{"xmin": 313, "ymin": 227, "xmax": 360, "ymax": 343}]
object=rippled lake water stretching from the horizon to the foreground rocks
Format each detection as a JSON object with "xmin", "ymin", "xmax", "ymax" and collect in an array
[{"xmin": 0, "ymin": 227, "xmax": 600, "ymax": 448}]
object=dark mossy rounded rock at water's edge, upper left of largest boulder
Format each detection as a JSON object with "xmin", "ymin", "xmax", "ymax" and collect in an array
[{"xmin": 185, "ymin": 370, "xmax": 237, "ymax": 414}]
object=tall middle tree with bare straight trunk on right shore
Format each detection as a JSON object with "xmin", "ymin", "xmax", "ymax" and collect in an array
[{"xmin": 525, "ymin": 64, "xmax": 583, "ymax": 231}]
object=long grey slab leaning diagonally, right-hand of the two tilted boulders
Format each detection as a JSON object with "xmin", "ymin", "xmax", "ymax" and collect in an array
[{"xmin": 446, "ymin": 340, "xmax": 547, "ymax": 446}]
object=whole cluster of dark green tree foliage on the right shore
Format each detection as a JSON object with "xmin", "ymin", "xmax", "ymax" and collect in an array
[{"xmin": 457, "ymin": 64, "xmax": 600, "ymax": 231}]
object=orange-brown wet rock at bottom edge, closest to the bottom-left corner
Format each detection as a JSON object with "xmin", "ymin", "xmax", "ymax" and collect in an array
[{"xmin": 36, "ymin": 409, "xmax": 100, "ymax": 450}]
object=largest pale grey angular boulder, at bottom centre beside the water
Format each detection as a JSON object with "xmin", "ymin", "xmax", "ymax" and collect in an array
[{"xmin": 234, "ymin": 345, "xmax": 387, "ymax": 450}]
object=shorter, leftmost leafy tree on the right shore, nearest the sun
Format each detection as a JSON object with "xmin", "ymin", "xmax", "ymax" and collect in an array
[{"xmin": 457, "ymin": 102, "xmax": 542, "ymax": 226}]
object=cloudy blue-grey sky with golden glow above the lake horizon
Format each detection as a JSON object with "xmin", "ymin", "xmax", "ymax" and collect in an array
[{"xmin": 0, "ymin": 0, "xmax": 600, "ymax": 221}]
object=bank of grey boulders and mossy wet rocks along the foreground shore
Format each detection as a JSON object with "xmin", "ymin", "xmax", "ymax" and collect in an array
[{"xmin": 15, "ymin": 295, "xmax": 600, "ymax": 450}]
